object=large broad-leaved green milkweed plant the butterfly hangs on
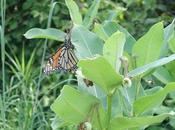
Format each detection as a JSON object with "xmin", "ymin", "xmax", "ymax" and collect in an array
[{"xmin": 24, "ymin": 0, "xmax": 175, "ymax": 130}]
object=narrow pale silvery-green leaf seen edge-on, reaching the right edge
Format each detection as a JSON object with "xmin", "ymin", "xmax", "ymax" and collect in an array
[{"xmin": 128, "ymin": 54, "xmax": 175, "ymax": 77}]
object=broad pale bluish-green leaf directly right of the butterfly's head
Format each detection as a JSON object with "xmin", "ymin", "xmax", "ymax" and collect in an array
[{"xmin": 72, "ymin": 25, "xmax": 103, "ymax": 59}]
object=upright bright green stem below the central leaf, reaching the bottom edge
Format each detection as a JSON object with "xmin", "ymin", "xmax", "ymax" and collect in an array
[{"xmin": 106, "ymin": 94, "xmax": 112, "ymax": 130}]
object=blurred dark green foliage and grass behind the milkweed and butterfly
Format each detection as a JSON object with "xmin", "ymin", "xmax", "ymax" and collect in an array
[{"xmin": 0, "ymin": 0, "xmax": 175, "ymax": 130}]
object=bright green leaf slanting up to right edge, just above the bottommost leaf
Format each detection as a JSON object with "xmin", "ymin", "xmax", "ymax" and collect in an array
[{"xmin": 133, "ymin": 83, "xmax": 175, "ymax": 116}]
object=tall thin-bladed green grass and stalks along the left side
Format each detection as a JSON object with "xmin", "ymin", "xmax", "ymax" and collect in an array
[{"xmin": 0, "ymin": 0, "xmax": 59, "ymax": 130}]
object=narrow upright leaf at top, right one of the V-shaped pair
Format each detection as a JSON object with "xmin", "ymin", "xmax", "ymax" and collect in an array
[{"xmin": 83, "ymin": 0, "xmax": 100, "ymax": 28}]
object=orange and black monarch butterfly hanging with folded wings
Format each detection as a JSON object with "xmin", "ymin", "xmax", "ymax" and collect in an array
[{"xmin": 44, "ymin": 32, "xmax": 78, "ymax": 74}]
